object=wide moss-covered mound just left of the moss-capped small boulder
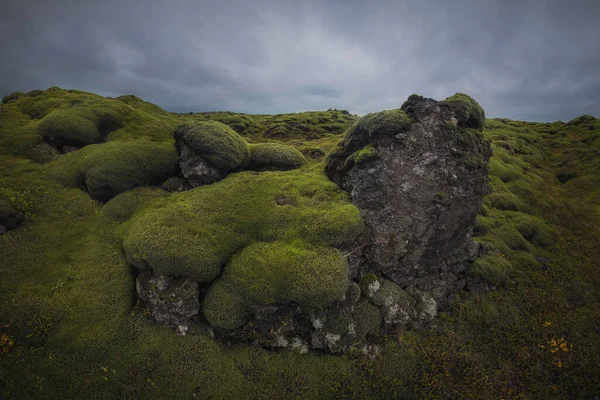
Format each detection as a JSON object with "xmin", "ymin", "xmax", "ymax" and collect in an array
[{"xmin": 80, "ymin": 140, "xmax": 177, "ymax": 201}]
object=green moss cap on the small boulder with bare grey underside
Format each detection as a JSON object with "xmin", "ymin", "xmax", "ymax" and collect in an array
[{"xmin": 174, "ymin": 121, "xmax": 250, "ymax": 170}]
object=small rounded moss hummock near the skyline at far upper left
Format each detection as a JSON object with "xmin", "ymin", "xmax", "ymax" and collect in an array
[{"xmin": 39, "ymin": 108, "xmax": 101, "ymax": 150}]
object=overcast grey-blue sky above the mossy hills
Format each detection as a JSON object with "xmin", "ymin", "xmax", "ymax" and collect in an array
[{"xmin": 0, "ymin": 0, "xmax": 600, "ymax": 121}]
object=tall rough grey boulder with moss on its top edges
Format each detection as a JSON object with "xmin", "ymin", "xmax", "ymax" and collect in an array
[{"xmin": 326, "ymin": 94, "xmax": 491, "ymax": 301}]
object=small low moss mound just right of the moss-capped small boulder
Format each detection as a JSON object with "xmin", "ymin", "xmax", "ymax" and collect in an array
[{"xmin": 249, "ymin": 143, "xmax": 307, "ymax": 171}]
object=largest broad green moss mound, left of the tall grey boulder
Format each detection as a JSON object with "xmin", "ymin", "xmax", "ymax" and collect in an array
[{"xmin": 123, "ymin": 170, "xmax": 362, "ymax": 282}]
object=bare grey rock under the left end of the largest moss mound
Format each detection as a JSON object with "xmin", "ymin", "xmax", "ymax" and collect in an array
[{"xmin": 136, "ymin": 271, "xmax": 200, "ymax": 335}]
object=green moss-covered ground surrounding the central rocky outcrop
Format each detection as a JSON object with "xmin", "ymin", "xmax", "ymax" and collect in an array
[{"xmin": 0, "ymin": 88, "xmax": 600, "ymax": 399}]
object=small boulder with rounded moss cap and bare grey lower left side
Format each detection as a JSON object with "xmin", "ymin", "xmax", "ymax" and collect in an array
[{"xmin": 173, "ymin": 121, "xmax": 250, "ymax": 187}]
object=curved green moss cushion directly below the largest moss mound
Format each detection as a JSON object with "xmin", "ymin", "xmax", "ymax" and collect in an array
[{"xmin": 203, "ymin": 242, "xmax": 348, "ymax": 329}]
